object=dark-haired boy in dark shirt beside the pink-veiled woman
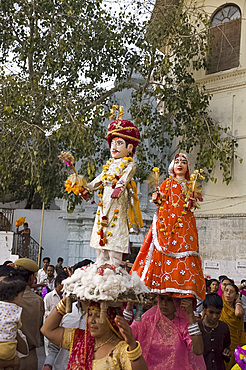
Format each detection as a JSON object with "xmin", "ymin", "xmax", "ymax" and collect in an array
[{"xmin": 198, "ymin": 293, "xmax": 231, "ymax": 370}]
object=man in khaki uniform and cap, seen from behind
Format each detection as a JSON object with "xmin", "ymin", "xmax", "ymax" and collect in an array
[{"xmin": 15, "ymin": 258, "xmax": 44, "ymax": 370}]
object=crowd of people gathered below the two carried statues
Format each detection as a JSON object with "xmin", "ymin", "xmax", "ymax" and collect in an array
[{"xmin": 0, "ymin": 257, "xmax": 246, "ymax": 370}]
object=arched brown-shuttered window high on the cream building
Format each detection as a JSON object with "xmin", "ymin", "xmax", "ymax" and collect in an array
[{"xmin": 207, "ymin": 4, "xmax": 241, "ymax": 74}]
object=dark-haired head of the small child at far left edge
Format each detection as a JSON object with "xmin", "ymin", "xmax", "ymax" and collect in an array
[{"xmin": 0, "ymin": 276, "xmax": 27, "ymax": 304}]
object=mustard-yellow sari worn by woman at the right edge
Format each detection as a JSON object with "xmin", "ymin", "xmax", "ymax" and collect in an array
[{"xmin": 220, "ymin": 296, "xmax": 246, "ymax": 370}]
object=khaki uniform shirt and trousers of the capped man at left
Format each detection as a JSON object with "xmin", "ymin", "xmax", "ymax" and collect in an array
[{"xmin": 19, "ymin": 286, "xmax": 44, "ymax": 370}]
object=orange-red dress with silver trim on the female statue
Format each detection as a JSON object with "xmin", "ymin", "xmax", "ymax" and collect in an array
[{"xmin": 132, "ymin": 178, "xmax": 206, "ymax": 299}]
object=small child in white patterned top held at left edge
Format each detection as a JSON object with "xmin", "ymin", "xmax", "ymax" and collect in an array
[{"xmin": 0, "ymin": 276, "xmax": 28, "ymax": 369}]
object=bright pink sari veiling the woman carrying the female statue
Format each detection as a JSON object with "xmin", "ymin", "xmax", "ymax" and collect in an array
[{"xmin": 131, "ymin": 302, "xmax": 206, "ymax": 370}]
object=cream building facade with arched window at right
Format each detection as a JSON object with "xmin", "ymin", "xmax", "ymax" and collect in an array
[{"xmin": 195, "ymin": 0, "xmax": 246, "ymax": 282}]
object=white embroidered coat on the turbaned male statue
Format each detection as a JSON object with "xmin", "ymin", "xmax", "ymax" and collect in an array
[{"xmin": 86, "ymin": 157, "xmax": 136, "ymax": 253}]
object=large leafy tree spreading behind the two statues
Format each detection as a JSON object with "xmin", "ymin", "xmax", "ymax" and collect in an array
[{"xmin": 0, "ymin": 0, "xmax": 238, "ymax": 207}]
